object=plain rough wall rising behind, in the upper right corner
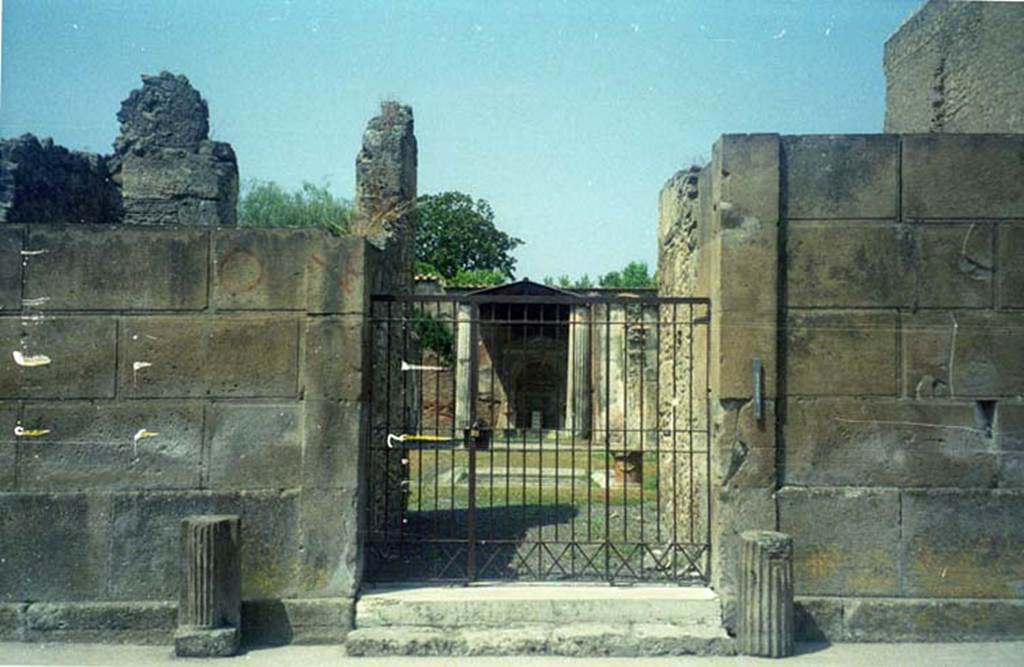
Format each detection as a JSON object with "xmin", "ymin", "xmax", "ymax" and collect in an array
[{"xmin": 885, "ymin": 0, "xmax": 1024, "ymax": 132}]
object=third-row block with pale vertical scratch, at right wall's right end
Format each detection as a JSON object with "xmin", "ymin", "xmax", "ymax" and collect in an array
[{"xmin": 903, "ymin": 312, "xmax": 1024, "ymax": 398}]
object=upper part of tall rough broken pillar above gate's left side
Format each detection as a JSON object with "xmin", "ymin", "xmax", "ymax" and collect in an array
[{"xmin": 352, "ymin": 101, "xmax": 417, "ymax": 293}]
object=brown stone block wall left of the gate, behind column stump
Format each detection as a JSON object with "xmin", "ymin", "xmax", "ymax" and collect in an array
[{"xmin": 0, "ymin": 224, "xmax": 379, "ymax": 641}]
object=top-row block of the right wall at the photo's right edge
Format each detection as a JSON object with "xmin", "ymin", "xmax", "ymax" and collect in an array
[{"xmin": 903, "ymin": 134, "xmax": 1024, "ymax": 219}]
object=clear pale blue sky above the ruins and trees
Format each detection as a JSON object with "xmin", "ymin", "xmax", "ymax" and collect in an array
[{"xmin": 0, "ymin": 0, "xmax": 921, "ymax": 279}]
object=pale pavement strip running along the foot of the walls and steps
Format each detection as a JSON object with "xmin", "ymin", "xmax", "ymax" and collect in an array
[{"xmin": 0, "ymin": 641, "xmax": 1024, "ymax": 667}]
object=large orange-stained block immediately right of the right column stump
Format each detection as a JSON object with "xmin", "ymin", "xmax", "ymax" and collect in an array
[{"xmin": 778, "ymin": 487, "xmax": 900, "ymax": 595}]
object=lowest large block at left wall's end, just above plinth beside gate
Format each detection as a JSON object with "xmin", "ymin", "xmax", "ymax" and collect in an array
[{"xmin": 296, "ymin": 487, "xmax": 366, "ymax": 597}]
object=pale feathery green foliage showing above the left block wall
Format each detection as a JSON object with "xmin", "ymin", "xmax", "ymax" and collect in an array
[{"xmin": 239, "ymin": 180, "xmax": 352, "ymax": 235}]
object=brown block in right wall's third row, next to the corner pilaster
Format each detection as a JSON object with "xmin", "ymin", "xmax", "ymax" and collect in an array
[{"xmin": 785, "ymin": 310, "xmax": 898, "ymax": 395}]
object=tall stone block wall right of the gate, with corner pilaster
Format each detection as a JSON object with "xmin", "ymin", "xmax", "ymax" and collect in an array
[{"xmin": 660, "ymin": 134, "xmax": 1024, "ymax": 640}]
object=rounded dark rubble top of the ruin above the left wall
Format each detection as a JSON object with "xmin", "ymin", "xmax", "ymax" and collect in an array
[{"xmin": 114, "ymin": 72, "xmax": 210, "ymax": 154}]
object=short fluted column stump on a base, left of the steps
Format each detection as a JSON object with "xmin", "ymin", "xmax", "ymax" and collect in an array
[{"xmin": 174, "ymin": 515, "xmax": 242, "ymax": 658}]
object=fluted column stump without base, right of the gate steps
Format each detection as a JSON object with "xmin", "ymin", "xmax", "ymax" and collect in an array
[{"xmin": 736, "ymin": 531, "xmax": 794, "ymax": 658}]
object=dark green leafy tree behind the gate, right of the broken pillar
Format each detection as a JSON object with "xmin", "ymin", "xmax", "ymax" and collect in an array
[{"xmin": 416, "ymin": 192, "xmax": 522, "ymax": 282}]
